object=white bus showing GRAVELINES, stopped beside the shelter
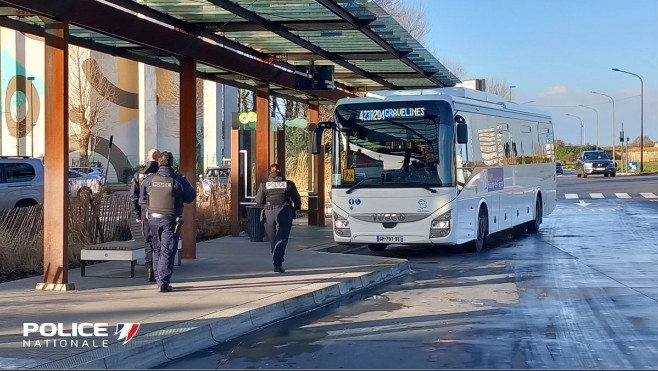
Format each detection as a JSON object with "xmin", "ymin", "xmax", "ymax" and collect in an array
[{"xmin": 312, "ymin": 88, "xmax": 556, "ymax": 251}]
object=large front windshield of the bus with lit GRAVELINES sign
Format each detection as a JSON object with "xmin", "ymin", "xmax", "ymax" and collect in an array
[{"xmin": 332, "ymin": 101, "xmax": 455, "ymax": 190}]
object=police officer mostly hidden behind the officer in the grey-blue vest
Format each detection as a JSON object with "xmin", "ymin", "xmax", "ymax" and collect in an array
[{"xmin": 130, "ymin": 148, "xmax": 160, "ymax": 282}]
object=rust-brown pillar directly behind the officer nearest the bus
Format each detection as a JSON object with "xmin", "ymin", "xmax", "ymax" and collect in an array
[{"xmin": 255, "ymin": 83, "xmax": 270, "ymax": 190}]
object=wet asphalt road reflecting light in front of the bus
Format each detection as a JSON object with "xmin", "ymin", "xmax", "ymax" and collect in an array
[{"xmin": 162, "ymin": 174, "xmax": 658, "ymax": 369}]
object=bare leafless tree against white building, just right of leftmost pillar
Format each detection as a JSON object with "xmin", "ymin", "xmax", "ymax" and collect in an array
[{"xmin": 69, "ymin": 46, "xmax": 117, "ymax": 165}]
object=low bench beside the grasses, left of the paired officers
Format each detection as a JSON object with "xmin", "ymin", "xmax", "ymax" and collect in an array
[{"xmin": 80, "ymin": 218, "xmax": 182, "ymax": 278}]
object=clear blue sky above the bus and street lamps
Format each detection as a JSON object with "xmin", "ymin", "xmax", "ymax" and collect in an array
[{"xmin": 406, "ymin": 0, "xmax": 658, "ymax": 148}]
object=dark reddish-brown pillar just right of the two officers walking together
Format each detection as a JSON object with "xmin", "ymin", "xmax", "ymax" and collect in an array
[{"xmin": 179, "ymin": 58, "xmax": 197, "ymax": 259}]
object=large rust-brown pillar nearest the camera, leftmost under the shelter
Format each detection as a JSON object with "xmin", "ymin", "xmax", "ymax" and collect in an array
[{"xmin": 36, "ymin": 21, "xmax": 75, "ymax": 291}]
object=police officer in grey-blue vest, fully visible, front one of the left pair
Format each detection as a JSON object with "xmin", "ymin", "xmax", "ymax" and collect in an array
[{"xmin": 139, "ymin": 152, "xmax": 196, "ymax": 292}]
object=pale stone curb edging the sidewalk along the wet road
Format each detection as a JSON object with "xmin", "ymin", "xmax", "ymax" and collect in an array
[{"xmin": 32, "ymin": 259, "xmax": 411, "ymax": 370}]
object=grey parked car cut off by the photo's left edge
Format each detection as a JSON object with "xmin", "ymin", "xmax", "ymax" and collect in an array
[{"xmin": 0, "ymin": 156, "xmax": 43, "ymax": 210}]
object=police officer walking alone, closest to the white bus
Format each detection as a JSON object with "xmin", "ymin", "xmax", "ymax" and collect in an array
[{"xmin": 256, "ymin": 164, "xmax": 302, "ymax": 273}]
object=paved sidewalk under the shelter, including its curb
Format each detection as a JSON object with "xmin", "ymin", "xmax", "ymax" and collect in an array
[{"xmin": 0, "ymin": 220, "xmax": 410, "ymax": 369}]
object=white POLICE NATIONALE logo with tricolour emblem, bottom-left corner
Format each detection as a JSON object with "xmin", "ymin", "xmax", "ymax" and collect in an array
[{"xmin": 23, "ymin": 322, "xmax": 140, "ymax": 348}]
